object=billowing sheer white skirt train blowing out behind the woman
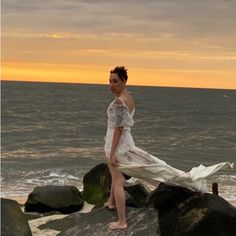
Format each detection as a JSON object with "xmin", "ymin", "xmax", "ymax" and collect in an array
[{"xmin": 116, "ymin": 147, "xmax": 233, "ymax": 192}]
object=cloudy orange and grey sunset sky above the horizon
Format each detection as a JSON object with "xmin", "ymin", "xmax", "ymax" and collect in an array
[{"xmin": 1, "ymin": 0, "xmax": 236, "ymax": 89}]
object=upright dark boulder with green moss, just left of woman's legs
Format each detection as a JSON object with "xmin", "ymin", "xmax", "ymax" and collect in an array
[{"xmin": 83, "ymin": 163, "xmax": 111, "ymax": 206}]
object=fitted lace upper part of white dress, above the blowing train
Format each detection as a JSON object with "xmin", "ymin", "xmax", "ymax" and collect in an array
[{"xmin": 104, "ymin": 98, "xmax": 135, "ymax": 157}]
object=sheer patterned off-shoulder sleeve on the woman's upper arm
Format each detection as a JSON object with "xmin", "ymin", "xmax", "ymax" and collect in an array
[{"xmin": 115, "ymin": 101, "xmax": 133, "ymax": 127}]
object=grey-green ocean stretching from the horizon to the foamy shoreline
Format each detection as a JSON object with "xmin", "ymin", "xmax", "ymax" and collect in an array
[{"xmin": 1, "ymin": 81, "xmax": 236, "ymax": 201}]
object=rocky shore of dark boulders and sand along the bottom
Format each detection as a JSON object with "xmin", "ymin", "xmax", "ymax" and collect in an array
[{"xmin": 1, "ymin": 164, "xmax": 236, "ymax": 236}]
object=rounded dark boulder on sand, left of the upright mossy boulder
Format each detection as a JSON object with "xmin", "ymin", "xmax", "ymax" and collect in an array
[{"xmin": 25, "ymin": 185, "xmax": 84, "ymax": 214}]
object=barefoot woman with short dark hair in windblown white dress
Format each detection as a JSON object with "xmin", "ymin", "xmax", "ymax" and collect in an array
[{"xmin": 104, "ymin": 66, "xmax": 233, "ymax": 229}]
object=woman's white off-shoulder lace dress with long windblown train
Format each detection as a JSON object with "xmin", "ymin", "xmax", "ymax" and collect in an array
[{"xmin": 104, "ymin": 98, "xmax": 233, "ymax": 192}]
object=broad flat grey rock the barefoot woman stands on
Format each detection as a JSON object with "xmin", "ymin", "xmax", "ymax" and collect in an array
[{"xmin": 39, "ymin": 207, "xmax": 160, "ymax": 236}]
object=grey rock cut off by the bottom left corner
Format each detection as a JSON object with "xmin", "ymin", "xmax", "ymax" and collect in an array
[{"xmin": 1, "ymin": 198, "xmax": 32, "ymax": 236}]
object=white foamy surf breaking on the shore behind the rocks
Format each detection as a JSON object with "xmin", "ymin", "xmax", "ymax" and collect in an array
[{"xmin": 1, "ymin": 169, "xmax": 236, "ymax": 202}]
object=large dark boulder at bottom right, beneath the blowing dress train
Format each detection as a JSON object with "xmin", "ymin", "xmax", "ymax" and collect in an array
[{"xmin": 147, "ymin": 183, "xmax": 236, "ymax": 236}]
